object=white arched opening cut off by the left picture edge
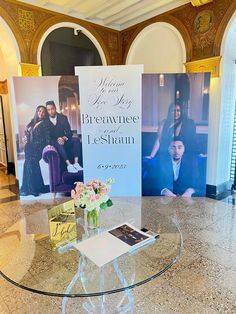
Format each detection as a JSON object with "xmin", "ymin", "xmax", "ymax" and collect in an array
[{"xmin": 0, "ymin": 17, "xmax": 20, "ymax": 173}]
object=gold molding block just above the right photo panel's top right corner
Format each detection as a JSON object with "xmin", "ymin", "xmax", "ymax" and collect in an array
[{"xmin": 184, "ymin": 56, "xmax": 221, "ymax": 77}]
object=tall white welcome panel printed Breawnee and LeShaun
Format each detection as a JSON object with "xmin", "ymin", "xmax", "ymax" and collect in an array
[{"xmin": 75, "ymin": 65, "xmax": 143, "ymax": 196}]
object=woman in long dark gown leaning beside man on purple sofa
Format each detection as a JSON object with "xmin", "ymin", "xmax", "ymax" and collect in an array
[{"xmin": 20, "ymin": 106, "xmax": 49, "ymax": 196}]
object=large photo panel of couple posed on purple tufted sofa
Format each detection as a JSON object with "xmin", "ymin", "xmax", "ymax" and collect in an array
[{"xmin": 13, "ymin": 76, "xmax": 83, "ymax": 199}]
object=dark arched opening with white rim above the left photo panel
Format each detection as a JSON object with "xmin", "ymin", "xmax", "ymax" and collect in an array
[{"xmin": 37, "ymin": 23, "xmax": 106, "ymax": 75}]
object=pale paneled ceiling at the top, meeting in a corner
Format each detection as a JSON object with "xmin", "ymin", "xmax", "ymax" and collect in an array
[{"xmin": 16, "ymin": 0, "xmax": 192, "ymax": 30}]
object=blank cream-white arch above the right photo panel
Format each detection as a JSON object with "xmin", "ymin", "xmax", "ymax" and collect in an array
[{"xmin": 126, "ymin": 22, "xmax": 186, "ymax": 73}]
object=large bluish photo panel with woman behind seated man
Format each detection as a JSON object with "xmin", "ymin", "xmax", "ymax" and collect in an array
[{"xmin": 142, "ymin": 73, "xmax": 210, "ymax": 197}]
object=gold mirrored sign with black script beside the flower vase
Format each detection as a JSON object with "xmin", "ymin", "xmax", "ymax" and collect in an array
[{"xmin": 48, "ymin": 201, "xmax": 77, "ymax": 249}]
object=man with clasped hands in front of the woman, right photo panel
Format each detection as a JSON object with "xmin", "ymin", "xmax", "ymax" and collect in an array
[{"xmin": 156, "ymin": 137, "xmax": 199, "ymax": 197}]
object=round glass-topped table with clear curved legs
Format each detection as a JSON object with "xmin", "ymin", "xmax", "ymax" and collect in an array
[{"xmin": 0, "ymin": 197, "xmax": 182, "ymax": 313}]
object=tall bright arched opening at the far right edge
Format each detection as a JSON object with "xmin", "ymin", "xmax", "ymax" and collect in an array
[{"xmin": 217, "ymin": 12, "xmax": 236, "ymax": 189}]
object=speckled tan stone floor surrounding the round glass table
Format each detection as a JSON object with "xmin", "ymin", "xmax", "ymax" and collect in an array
[{"xmin": 0, "ymin": 170, "xmax": 236, "ymax": 314}]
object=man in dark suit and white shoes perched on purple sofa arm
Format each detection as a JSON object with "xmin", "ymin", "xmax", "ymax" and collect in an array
[{"xmin": 46, "ymin": 100, "xmax": 82, "ymax": 173}]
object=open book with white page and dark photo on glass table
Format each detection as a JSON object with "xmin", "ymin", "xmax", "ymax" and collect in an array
[{"xmin": 74, "ymin": 222, "xmax": 155, "ymax": 267}]
